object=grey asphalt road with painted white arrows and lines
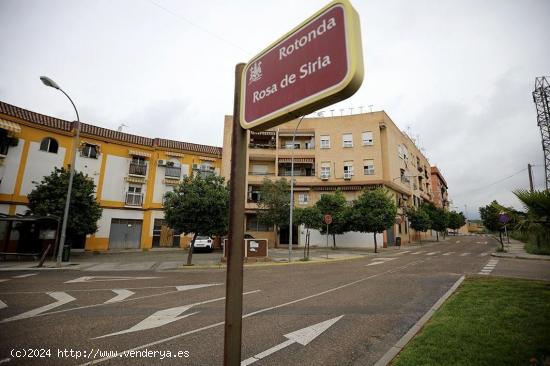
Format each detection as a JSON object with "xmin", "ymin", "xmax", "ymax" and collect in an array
[{"xmin": 0, "ymin": 236, "xmax": 550, "ymax": 365}]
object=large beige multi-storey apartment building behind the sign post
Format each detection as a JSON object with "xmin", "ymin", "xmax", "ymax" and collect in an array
[{"xmin": 222, "ymin": 111, "xmax": 444, "ymax": 247}]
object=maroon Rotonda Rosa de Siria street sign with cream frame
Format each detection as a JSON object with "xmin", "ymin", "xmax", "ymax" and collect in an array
[{"xmin": 240, "ymin": 0, "xmax": 363, "ymax": 131}]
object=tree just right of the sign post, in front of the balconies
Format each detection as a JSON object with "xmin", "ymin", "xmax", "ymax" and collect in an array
[{"xmin": 258, "ymin": 178, "xmax": 290, "ymax": 246}]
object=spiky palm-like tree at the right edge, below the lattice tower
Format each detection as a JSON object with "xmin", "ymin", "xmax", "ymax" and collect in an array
[{"xmin": 514, "ymin": 190, "xmax": 550, "ymax": 249}]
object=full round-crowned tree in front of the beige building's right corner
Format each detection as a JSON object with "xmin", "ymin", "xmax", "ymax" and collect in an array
[{"xmin": 350, "ymin": 188, "xmax": 397, "ymax": 253}]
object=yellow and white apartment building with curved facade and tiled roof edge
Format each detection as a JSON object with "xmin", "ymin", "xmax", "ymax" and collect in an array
[{"xmin": 0, "ymin": 102, "xmax": 222, "ymax": 250}]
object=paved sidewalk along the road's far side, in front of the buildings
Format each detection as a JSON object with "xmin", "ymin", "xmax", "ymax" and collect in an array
[{"xmin": 0, "ymin": 241, "xmax": 444, "ymax": 271}]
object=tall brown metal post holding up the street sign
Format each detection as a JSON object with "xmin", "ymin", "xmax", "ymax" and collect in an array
[{"xmin": 223, "ymin": 64, "xmax": 248, "ymax": 366}]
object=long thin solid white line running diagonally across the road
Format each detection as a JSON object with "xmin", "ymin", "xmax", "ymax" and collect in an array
[{"xmin": 79, "ymin": 260, "xmax": 424, "ymax": 366}]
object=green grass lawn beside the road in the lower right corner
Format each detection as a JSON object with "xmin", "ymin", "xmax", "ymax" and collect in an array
[{"xmin": 392, "ymin": 278, "xmax": 550, "ymax": 366}]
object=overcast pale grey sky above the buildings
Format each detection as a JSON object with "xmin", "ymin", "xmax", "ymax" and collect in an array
[{"xmin": 0, "ymin": 0, "xmax": 550, "ymax": 218}]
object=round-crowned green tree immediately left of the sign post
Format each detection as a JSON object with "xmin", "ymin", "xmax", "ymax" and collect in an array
[{"xmin": 164, "ymin": 174, "xmax": 229, "ymax": 266}]
